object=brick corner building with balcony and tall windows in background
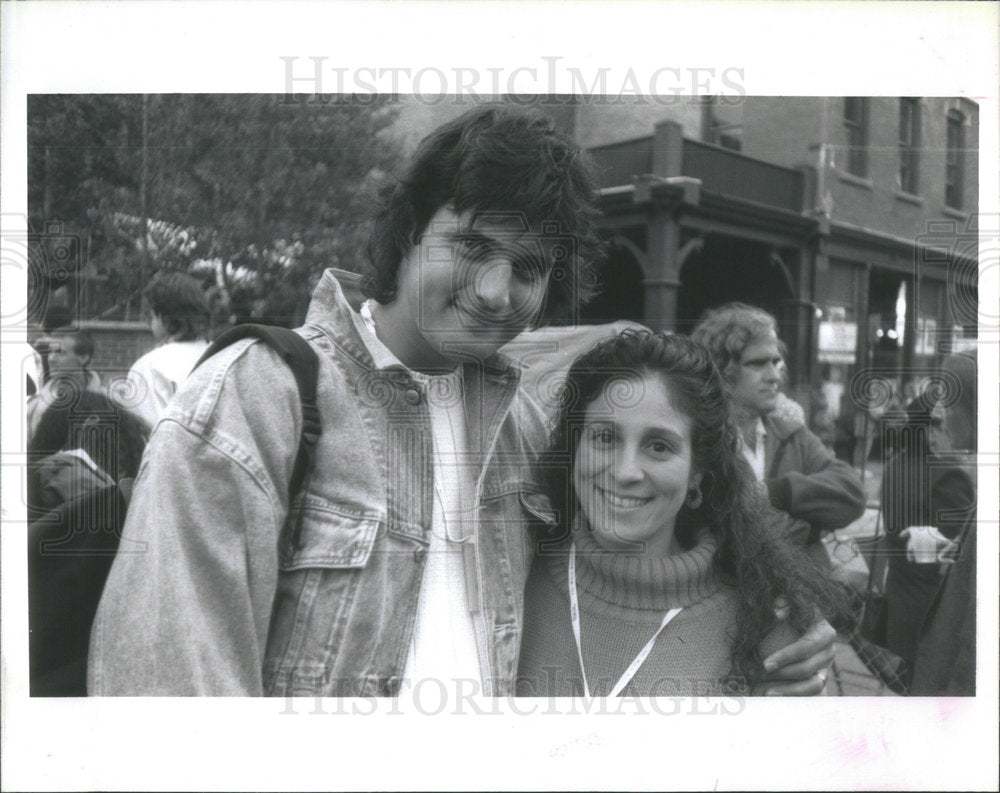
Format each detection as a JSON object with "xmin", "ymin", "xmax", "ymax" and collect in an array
[{"xmin": 574, "ymin": 97, "xmax": 979, "ymax": 462}]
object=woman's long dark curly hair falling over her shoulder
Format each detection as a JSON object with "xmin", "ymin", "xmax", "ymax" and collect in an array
[{"xmin": 541, "ymin": 329, "xmax": 843, "ymax": 687}]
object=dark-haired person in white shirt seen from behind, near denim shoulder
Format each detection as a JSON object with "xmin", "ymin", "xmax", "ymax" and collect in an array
[{"xmin": 119, "ymin": 273, "xmax": 211, "ymax": 434}]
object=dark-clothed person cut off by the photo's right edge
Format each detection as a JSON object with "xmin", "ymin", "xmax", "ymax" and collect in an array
[{"xmin": 904, "ymin": 351, "xmax": 977, "ymax": 696}]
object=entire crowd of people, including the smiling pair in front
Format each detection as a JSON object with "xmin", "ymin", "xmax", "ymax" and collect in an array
[{"xmin": 28, "ymin": 106, "xmax": 975, "ymax": 696}]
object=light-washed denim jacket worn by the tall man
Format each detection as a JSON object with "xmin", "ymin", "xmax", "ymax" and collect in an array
[{"xmin": 88, "ymin": 272, "xmax": 552, "ymax": 696}]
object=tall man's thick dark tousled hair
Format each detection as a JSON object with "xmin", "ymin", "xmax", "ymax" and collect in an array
[{"xmin": 364, "ymin": 104, "xmax": 603, "ymax": 324}]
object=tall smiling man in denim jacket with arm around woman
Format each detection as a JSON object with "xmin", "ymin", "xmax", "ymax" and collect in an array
[{"xmin": 90, "ymin": 106, "xmax": 832, "ymax": 696}]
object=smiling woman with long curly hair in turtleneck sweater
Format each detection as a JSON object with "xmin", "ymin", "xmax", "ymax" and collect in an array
[{"xmin": 518, "ymin": 330, "xmax": 839, "ymax": 696}]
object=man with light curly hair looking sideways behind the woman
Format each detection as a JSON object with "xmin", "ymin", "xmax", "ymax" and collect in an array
[{"xmin": 691, "ymin": 303, "xmax": 865, "ymax": 569}]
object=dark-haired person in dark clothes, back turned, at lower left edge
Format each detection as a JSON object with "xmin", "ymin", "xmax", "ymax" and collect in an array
[{"xmin": 27, "ymin": 391, "xmax": 146, "ymax": 697}]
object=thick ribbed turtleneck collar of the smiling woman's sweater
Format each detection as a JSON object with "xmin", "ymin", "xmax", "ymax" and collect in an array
[{"xmin": 547, "ymin": 525, "xmax": 720, "ymax": 612}]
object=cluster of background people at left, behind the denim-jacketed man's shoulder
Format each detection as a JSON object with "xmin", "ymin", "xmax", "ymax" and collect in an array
[{"xmin": 26, "ymin": 273, "xmax": 209, "ymax": 696}]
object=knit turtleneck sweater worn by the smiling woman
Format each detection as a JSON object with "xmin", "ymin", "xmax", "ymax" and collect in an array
[{"xmin": 517, "ymin": 529, "xmax": 796, "ymax": 697}]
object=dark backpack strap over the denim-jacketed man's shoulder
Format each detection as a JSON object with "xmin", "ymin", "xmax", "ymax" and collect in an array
[{"xmin": 193, "ymin": 324, "xmax": 323, "ymax": 548}]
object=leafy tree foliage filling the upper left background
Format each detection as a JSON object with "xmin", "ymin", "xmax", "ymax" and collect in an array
[{"xmin": 28, "ymin": 94, "xmax": 399, "ymax": 325}]
